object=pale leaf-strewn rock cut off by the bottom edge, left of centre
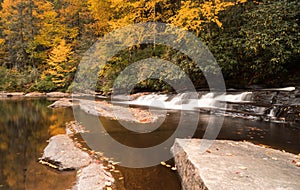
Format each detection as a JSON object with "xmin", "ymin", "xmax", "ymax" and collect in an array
[{"xmin": 72, "ymin": 163, "xmax": 114, "ymax": 190}]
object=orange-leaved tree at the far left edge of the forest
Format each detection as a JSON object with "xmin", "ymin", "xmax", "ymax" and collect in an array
[{"xmin": 0, "ymin": 0, "xmax": 32, "ymax": 68}]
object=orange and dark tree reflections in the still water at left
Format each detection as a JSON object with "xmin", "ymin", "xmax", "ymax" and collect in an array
[{"xmin": 0, "ymin": 99, "xmax": 75, "ymax": 189}]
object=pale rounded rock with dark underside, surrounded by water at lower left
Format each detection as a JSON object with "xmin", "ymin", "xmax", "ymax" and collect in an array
[{"xmin": 41, "ymin": 135, "xmax": 92, "ymax": 170}]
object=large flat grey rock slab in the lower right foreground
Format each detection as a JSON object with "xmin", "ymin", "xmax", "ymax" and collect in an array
[{"xmin": 171, "ymin": 139, "xmax": 300, "ymax": 190}]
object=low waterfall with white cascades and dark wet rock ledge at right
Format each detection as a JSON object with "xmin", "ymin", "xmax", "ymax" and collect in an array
[{"xmin": 114, "ymin": 87, "xmax": 300, "ymax": 125}]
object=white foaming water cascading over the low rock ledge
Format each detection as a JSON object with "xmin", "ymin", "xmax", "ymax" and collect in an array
[{"xmin": 119, "ymin": 92, "xmax": 252, "ymax": 110}]
